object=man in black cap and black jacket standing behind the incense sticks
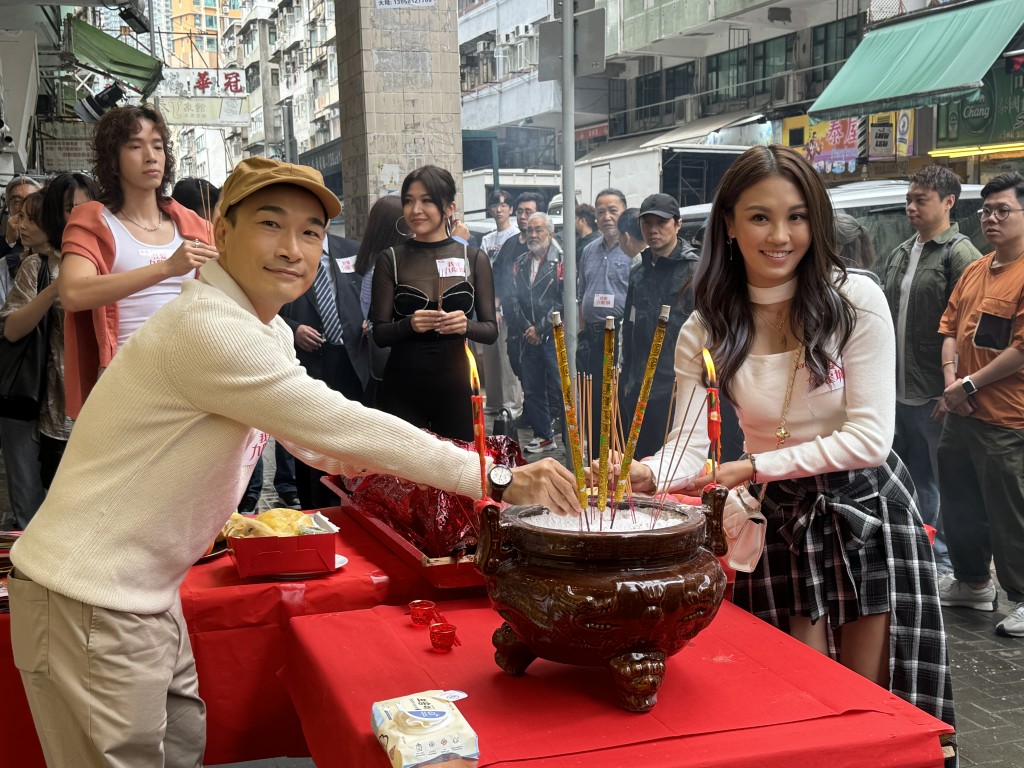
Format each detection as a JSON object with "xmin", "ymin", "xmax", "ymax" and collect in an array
[{"xmin": 621, "ymin": 194, "xmax": 699, "ymax": 458}]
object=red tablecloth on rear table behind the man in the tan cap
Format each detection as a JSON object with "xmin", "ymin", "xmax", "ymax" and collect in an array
[{"xmin": 0, "ymin": 508, "xmax": 467, "ymax": 768}]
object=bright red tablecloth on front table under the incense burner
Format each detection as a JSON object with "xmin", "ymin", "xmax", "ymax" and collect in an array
[{"xmin": 284, "ymin": 600, "xmax": 950, "ymax": 768}]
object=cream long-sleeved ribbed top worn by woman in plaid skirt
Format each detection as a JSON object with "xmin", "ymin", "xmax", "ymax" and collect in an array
[{"xmin": 644, "ymin": 274, "xmax": 896, "ymax": 489}]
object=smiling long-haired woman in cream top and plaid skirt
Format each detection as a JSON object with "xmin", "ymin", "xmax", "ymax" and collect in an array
[{"xmin": 630, "ymin": 146, "xmax": 953, "ymax": 741}]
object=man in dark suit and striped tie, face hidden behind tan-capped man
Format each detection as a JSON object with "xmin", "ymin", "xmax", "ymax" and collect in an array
[{"xmin": 281, "ymin": 234, "xmax": 370, "ymax": 509}]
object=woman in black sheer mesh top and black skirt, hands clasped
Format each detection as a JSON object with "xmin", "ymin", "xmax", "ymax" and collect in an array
[{"xmin": 370, "ymin": 165, "xmax": 498, "ymax": 441}]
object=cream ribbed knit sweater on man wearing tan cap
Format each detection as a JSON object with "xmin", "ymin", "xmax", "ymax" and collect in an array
[{"xmin": 11, "ymin": 261, "xmax": 480, "ymax": 613}]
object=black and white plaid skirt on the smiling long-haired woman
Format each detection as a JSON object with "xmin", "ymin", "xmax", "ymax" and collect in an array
[{"xmin": 733, "ymin": 453, "xmax": 954, "ymax": 725}]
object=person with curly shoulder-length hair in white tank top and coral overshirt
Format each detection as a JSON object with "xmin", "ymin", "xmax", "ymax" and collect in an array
[{"xmin": 58, "ymin": 106, "xmax": 217, "ymax": 418}]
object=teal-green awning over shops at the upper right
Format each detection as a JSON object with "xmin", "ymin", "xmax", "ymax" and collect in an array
[{"xmin": 807, "ymin": 0, "xmax": 1024, "ymax": 120}]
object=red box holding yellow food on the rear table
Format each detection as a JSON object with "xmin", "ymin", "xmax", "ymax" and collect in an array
[{"xmin": 227, "ymin": 534, "xmax": 338, "ymax": 579}]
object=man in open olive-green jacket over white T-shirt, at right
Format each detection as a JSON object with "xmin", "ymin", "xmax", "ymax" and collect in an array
[{"xmin": 878, "ymin": 165, "xmax": 981, "ymax": 571}]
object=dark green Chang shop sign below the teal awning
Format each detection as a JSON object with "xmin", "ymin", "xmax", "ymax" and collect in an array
[{"xmin": 936, "ymin": 59, "xmax": 1024, "ymax": 150}]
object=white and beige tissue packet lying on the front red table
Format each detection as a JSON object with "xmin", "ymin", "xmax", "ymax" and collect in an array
[{"xmin": 371, "ymin": 690, "xmax": 480, "ymax": 768}]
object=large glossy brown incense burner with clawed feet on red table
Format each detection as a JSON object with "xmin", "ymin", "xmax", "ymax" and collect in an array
[{"xmin": 476, "ymin": 497, "xmax": 726, "ymax": 712}]
